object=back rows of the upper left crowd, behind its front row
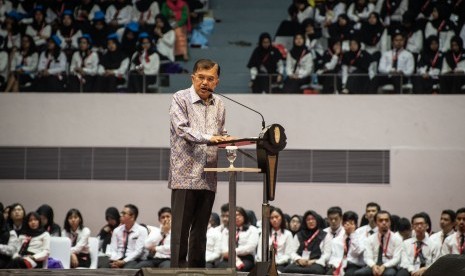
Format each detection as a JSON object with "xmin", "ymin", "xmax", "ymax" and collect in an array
[{"xmin": 0, "ymin": 0, "xmax": 203, "ymax": 62}]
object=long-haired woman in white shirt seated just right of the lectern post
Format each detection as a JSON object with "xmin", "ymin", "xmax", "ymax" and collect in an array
[{"xmin": 256, "ymin": 207, "xmax": 294, "ymax": 272}]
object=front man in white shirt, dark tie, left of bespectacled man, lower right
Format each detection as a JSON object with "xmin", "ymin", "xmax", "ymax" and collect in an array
[{"xmin": 354, "ymin": 210, "xmax": 402, "ymax": 276}]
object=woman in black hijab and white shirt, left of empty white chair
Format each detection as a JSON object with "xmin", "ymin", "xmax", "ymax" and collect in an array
[{"xmin": 8, "ymin": 212, "xmax": 50, "ymax": 269}]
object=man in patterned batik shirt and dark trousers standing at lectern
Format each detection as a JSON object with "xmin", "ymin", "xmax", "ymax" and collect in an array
[{"xmin": 168, "ymin": 59, "xmax": 228, "ymax": 268}]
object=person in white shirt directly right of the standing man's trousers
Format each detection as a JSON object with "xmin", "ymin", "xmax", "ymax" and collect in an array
[{"xmin": 205, "ymin": 213, "xmax": 223, "ymax": 268}]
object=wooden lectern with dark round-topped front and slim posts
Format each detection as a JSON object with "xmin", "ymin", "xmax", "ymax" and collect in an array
[{"xmin": 205, "ymin": 124, "xmax": 287, "ymax": 276}]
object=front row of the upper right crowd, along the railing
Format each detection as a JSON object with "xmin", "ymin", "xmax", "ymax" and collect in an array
[{"xmin": 248, "ymin": 32, "xmax": 465, "ymax": 94}]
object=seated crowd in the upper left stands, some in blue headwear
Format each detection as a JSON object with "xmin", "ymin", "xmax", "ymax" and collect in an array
[{"xmin": 0, "ymin": 0, "xmax": 203, "ymax": 92}]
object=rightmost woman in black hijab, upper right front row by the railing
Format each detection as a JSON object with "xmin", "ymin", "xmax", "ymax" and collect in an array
[{"xmin": 439, "ymin": 36, "xmax": 465, "ymax": 94}]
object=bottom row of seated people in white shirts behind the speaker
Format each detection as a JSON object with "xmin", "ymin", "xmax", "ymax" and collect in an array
[{"xmin": 0, "ymin": 202, "xmax": 465, "ymax": 276}]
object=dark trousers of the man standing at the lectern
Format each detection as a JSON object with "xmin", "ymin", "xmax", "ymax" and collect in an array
[{"xmin": 171, "ymin": 189, "xmax": 215, "ymax": 267}]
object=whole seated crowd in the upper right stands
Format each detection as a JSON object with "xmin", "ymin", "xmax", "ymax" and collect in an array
[{"xmin": 247, "ymin": 0, "xmax": 465, "ymax": 94}]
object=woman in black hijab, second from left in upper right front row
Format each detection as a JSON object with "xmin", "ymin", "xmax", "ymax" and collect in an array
[{"xmin": 283, "ymin": 33, "xmax": 313, "ymax": 93}]
